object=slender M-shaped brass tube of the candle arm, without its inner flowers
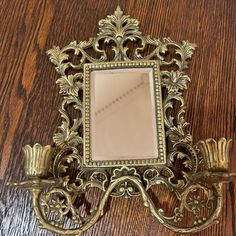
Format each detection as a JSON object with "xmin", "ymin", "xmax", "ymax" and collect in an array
[{"xmin": 21, "ymin": 176, "xmax": 222, "ymax": 235}]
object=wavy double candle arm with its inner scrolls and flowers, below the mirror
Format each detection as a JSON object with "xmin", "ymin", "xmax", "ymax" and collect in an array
[{"xmin": 9, "ymin": 173, "xmax": 225, "ymax": 235}]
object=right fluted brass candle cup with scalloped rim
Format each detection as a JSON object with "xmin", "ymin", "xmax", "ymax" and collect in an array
[{"xmin": 198, "ymin": 138, "xmax": 232, "ymax": 172}]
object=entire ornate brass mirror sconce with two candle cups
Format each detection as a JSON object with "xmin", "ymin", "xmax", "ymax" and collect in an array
[{"xmin": 10, "ymin": 7, "xmax": 235, "ymax": 235}]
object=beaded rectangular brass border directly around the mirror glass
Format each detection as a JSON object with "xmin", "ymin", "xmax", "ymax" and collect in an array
[{"xmin": 83, "ymin": 60, "xmax": 166, "ymax": 168}]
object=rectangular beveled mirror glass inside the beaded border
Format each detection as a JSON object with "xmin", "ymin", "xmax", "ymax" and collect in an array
[{"xmin": 90, "ymin": 68, "xmax": 158, "ymax": 161}]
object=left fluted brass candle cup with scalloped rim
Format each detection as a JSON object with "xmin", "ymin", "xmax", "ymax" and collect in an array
[{"xmin": 23, "ymin": 143, "xmax": 52, "ymax": 178}]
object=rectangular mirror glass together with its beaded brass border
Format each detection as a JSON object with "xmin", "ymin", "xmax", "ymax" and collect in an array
[{"xmin": 84, "ymin": 61, "xmax": 165, "ymax": 166}]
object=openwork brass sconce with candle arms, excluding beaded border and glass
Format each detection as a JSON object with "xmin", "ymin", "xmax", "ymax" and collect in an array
[{"xmin": 7, "ymin": 7, "xmax": 235, "ymax": 235}]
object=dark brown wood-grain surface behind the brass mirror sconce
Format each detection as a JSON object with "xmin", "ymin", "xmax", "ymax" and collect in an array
[{"xmin": 0, "ymin": 0, "xmax": 236, "ymax": 236}]
